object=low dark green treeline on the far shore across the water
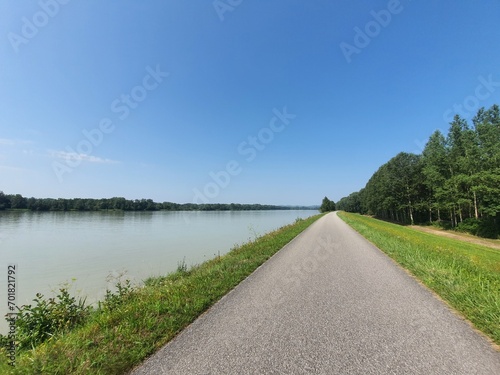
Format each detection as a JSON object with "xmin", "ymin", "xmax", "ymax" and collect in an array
[{"xmin": 0, "ymin": 191, "xmax": 318, "ymax": 211}]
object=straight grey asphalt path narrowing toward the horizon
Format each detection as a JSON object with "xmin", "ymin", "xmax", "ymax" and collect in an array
[{"xmin": 133, "ymin": 213, "xmax": 500, "ymax": 375}]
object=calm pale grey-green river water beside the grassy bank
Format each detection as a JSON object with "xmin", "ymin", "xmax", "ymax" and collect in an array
[{"xmin": 0, "ymin": 210, "xmax": 317, "ymax": 333}]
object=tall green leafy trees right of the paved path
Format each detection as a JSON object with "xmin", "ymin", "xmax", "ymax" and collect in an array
[{"xmin": 337, "ymin": 104, "xmax": 500, "ymax": 238}]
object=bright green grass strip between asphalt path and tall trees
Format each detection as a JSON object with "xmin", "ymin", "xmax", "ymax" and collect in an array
[{"xmin": 339, "ymin": 212, "xmax": 500, "ymax": 344}]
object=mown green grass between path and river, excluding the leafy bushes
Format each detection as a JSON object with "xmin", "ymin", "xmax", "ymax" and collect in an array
[{"xmin": 0, "ymin": 215, "xmax": 322, "ymax": 374}]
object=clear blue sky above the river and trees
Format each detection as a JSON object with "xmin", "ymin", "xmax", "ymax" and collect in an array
[{"xmin": 0, "ymin": 0, "xmax": 500, "ymax": 205}]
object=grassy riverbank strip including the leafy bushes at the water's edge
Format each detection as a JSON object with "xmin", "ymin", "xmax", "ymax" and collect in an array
[{"xmin": 0, "ymin": 214, "xmax": 323, "ymax": 374}]
